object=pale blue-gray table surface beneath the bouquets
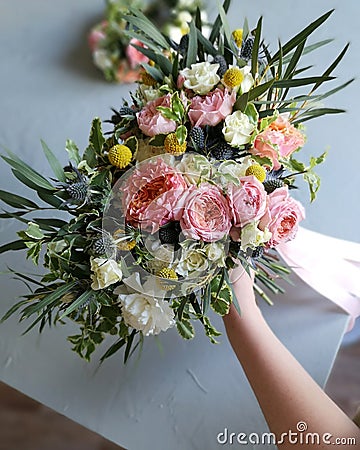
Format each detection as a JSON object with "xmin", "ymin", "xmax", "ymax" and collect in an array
[{"xmin": 0, "ymin": 0, "xmax": 360, "ymax": 450}]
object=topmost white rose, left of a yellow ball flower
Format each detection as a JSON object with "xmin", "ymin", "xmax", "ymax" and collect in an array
[{"xmin": 180, "ymin": 61, "xmax": 220, "ymax": 95}]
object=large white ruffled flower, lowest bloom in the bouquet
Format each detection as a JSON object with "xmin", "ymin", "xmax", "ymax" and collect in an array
[{"xmin": 115, "ymin": 273, "xmax": 175, "ymax": 336}]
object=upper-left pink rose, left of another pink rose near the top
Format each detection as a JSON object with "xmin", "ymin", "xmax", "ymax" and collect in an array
[{"xmin": 137, "ymin": 94, "xmax": 176, "ymax": 136}]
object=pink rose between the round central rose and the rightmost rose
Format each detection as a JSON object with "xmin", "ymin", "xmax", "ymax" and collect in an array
[{"xmin": 228, "ymin": 175, "xmax": 267, "ymax": 227}]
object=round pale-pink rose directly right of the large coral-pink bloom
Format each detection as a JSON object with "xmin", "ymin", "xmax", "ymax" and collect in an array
[{"xmin": 180, "ymin": 183, "xmax": 231, "ymax": 242}]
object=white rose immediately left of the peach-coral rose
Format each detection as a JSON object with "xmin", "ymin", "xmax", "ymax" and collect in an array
[{"xmin": 222, "ymin": 111, "xmax": 255, "ymax": 147}]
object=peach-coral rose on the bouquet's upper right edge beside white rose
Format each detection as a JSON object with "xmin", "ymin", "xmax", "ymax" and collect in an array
[{"xmin": 250, "ymin": 115, "xmax": 305, "ymax": 170}]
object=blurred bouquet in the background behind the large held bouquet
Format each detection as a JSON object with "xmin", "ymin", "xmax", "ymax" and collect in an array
[{"xmin": 88, "ymin": 0, "xmax": 205, "ymax": 83}]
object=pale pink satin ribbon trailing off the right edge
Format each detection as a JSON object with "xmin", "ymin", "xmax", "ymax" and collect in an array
[{"xmin": 276, "ymin": 227, "xmax": 360, "ymax": 331}]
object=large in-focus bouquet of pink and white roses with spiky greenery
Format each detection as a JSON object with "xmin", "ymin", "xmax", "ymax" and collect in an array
[{"xmin": 0, "ymin": 0, "xmax": 350, "ymax": 361}]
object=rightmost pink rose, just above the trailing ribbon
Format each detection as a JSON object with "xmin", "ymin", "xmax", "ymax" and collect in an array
[{"xmin": 262, "ymin": 187, "xmax": 305, "ymax": 247}]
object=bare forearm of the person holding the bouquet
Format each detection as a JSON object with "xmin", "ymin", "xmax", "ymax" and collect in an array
[{"xmin": 224, "ymin": 304, "xmax": 360, "ymax": 449}]
